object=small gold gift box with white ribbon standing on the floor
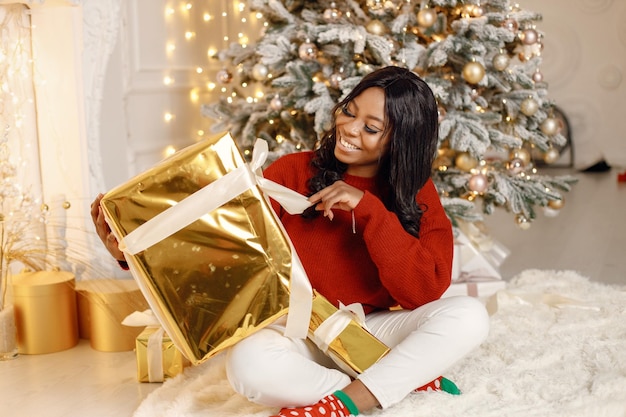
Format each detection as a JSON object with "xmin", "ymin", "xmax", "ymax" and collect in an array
[{"xmin": 135, "ymin": 326, "xmax": 185, "ymax": 382}]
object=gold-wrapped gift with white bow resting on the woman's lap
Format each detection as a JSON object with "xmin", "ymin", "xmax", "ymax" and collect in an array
[{"xmin": 309, "ymin": 292, "xmax": 389, "ymax": 377}]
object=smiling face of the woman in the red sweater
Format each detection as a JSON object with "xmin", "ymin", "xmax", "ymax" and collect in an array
[{"xmin": 335, "ymin": 87, "xmax": 389, "ymax": 177}]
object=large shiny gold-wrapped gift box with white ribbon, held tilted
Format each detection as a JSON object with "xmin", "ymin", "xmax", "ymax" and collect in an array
[{"xmin": 101, "ymin": 134, "xmax": 312, "ymax": 364}]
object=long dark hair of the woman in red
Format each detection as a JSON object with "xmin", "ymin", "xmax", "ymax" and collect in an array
[{"xmin": 304, "ymin": 66, "xmax": 438, "ymax": 237}]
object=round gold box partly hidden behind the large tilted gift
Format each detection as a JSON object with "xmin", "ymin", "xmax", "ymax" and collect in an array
[{"xmin": 76, "ymin": 278, "xmax": 148, "ymax": 352}]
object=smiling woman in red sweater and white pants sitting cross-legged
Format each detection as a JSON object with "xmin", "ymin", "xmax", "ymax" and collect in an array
[{"xmin": 92, "ymin": 66, "xmax": 488, "ymax": 417}]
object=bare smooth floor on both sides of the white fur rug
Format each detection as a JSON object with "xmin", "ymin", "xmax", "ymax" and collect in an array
[{"xmin": 0, "ymin": 170, "xmax": 626, "ymax": 417}]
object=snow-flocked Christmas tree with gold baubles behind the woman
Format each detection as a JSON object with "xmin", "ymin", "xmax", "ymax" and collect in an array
[{"xmin": 203, "ymin": 0, "xmax": 575, "ymax": 228}]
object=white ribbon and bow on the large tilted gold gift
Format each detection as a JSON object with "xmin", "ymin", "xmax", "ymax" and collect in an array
[{"xmin": 119, "ymin": 139, "xmax": 313, "ymax": 339}]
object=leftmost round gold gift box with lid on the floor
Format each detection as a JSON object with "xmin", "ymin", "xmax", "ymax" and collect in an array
[{"xmin": 12, "ymin": 271, "xmax": 78, "ymax": 355}]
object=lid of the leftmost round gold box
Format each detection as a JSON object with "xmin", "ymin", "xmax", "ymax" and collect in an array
[{"xmin": 12, "ymin": 271, "xmax": 75, "ymax": 297}]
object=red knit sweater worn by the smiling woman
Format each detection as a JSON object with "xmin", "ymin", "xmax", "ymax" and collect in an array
[{"xmin": 264, "ymin": 152, "xmax": 453, "ymax": 313}]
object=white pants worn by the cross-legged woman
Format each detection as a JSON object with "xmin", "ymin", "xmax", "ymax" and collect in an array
[{"xmin": 226, "ymin": 296, "xmax": 489, "ymax": 408}]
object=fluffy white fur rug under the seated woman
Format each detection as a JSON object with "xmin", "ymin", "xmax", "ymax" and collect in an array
[{"xmin": 134, "ymin": 270, "xmax": 626, "ymax": 417}]
